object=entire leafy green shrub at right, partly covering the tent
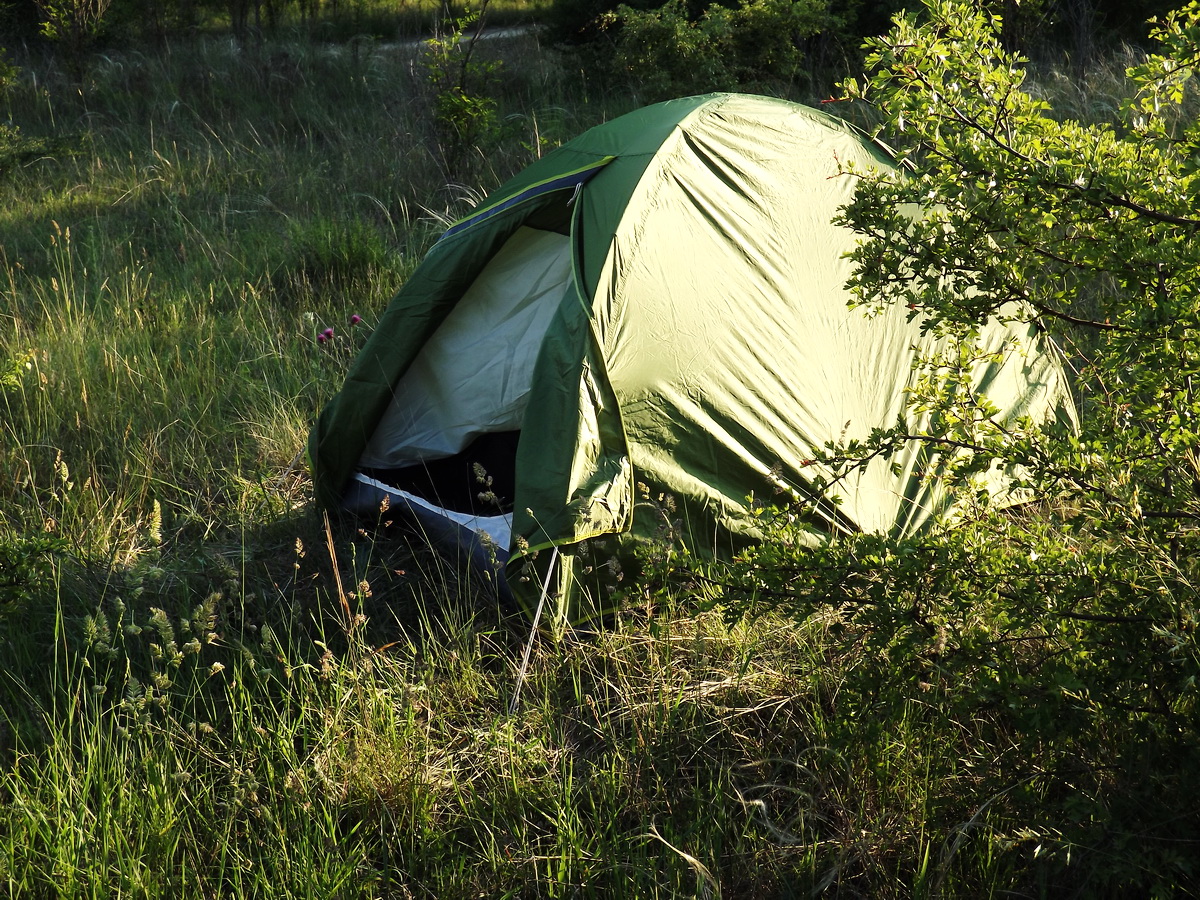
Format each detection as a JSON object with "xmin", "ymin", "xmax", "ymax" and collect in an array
[{"xmin": 648, "ymin": 0, "xmax": 1200, "ymax": 896}]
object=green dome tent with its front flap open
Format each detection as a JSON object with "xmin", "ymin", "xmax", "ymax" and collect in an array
[{"xmin": 310, "ymin": 95, "xmax": 1073, "ymax": 622}]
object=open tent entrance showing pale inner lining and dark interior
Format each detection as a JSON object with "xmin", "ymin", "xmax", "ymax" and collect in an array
[{"xmin": 347, "ymin": 223, "xmax": 571, "ymax": 558}]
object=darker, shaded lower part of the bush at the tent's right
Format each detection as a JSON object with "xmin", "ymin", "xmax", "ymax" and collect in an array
[{"xmin": 686, "ymin": 511, "xmax": 1200, "ymax": 895}]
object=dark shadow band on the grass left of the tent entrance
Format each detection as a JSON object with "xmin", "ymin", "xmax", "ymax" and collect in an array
[{"xmin": 0, "ymin": 508, "xmax": 528, "ymax": 770}]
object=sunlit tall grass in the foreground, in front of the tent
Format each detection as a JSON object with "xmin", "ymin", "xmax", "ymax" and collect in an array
[{"xmin": 0, "ymin": 549, "xmax": 1022, "ymax": 898}]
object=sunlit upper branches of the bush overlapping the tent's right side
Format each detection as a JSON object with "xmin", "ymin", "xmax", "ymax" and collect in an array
[{"xmin": 844, "ymin": 1, "xmax": 1200, "ymax": 556}]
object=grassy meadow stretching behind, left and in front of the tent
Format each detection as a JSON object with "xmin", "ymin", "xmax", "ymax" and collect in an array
[{"xmin": 0, "ymin": 10, "xmax": 1190, "ymax": 898}]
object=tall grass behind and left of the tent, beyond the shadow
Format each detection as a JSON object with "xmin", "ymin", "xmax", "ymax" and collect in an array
[{"xmin": 0, "ymin": 30, "xmax": 588, "ymax": 540}]
